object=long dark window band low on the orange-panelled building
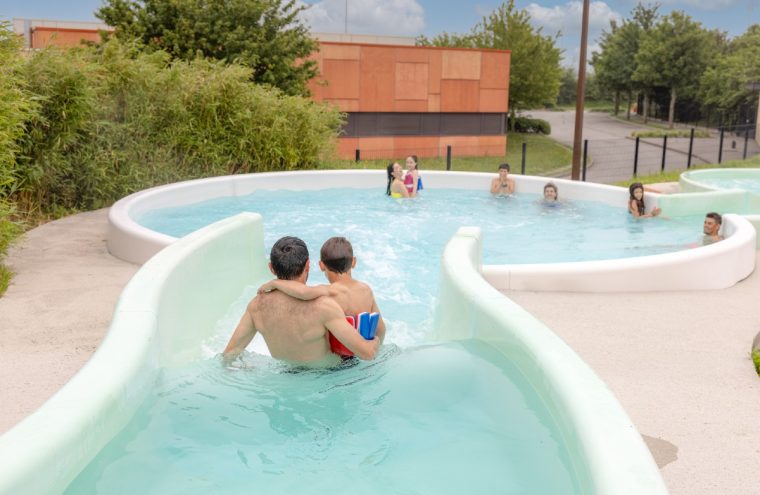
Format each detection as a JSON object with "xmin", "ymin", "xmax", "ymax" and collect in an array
[{"xmin": 342, "ymin": 112, "xmax": 505, "ymax": 137}]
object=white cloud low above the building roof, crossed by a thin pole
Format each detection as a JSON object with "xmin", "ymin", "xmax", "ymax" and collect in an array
[{"xmin": 301, "ymin": 0, "xmax": 425, "ymax": 36}]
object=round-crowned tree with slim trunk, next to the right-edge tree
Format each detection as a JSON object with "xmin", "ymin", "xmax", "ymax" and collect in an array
[{"xmin": 633, "ymin": 11, "xmax": 713, "ymax": 128}]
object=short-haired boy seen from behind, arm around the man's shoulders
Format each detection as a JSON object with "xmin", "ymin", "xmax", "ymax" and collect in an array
[{"xmin": 258, "ymin": 237, "xmax": 385, "ymax": 352}]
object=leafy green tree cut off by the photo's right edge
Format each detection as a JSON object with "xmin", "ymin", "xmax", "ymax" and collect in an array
[{"xmin": 699, "ymin": 24, "xmax": 760, "ymax": 127}]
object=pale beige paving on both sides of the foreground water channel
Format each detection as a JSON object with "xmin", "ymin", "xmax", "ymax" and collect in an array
[{"xmin": 0, "ymin": 209, "xmax": 760, "ymax": 494}]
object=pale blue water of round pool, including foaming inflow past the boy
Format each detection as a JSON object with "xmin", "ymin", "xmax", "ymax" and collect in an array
[{"xmin": 136, "ymin": 189, "xmax": 703, "ymax": 347}]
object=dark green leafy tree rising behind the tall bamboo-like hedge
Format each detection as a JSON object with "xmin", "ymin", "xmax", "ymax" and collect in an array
[{"xmin": 96, "ymin": 0, "xmax": 317, "ymax": 95}]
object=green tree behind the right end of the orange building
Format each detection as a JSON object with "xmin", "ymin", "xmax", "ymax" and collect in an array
[{"xmin": 418, "ymin": 0, "xmax": 562, "ymax": 130}]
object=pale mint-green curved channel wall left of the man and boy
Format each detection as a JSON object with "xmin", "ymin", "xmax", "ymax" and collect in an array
[{"xmin": 0, "ymin": 213, "xmax": 267, "ymax": 495}]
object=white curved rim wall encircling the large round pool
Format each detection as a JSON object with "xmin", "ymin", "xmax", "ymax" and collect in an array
[{"xmin": 108, "ymin": 169, "xmax": 757, "ymax": 292}]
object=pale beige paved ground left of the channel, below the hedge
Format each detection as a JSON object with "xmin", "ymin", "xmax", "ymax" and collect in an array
[{"xmin": 0, "ymin": 209, "xmax": 139, "ymax": 433}]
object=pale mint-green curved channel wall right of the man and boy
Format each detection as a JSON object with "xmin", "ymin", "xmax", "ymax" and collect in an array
[{"xmin": 434, "ymin": 227, "xmax": 667, "ymax": 495}]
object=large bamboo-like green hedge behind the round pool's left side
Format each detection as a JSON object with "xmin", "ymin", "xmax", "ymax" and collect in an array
[{"xmin": 13, "ymin": 36, "xmax": 343, "ymax": 213}]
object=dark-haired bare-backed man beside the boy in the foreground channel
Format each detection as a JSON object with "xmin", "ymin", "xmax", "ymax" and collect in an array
[{"xmin": 224, "ymin": 237, "xmax": 380, "ymax": 366}]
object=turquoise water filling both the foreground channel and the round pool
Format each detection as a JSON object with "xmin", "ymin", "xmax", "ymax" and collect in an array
[{"xmin": 66, "ymin": 189, "xmax": 702, "ymax": 494}]
